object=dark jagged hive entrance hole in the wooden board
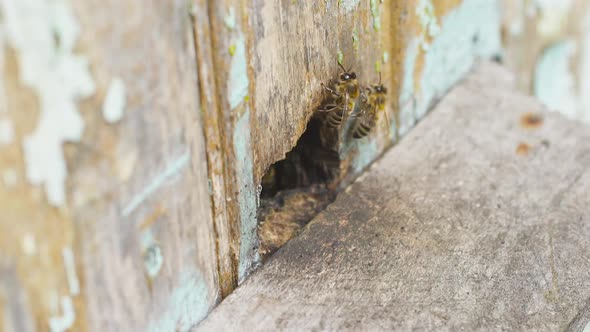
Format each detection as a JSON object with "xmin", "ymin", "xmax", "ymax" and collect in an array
[{"xmin": 257, "ymin": 117, "xmax": 340, "ymax": 260}]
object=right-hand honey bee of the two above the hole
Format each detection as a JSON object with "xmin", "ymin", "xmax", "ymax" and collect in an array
[{"xmin": 352, "ymin": 74, "xmax": 389, "ymax": 139}]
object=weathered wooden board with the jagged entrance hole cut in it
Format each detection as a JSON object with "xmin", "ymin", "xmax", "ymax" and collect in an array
[{"xmin": 200, "ymin": 0, "xmax": 500, "ymax": 294}]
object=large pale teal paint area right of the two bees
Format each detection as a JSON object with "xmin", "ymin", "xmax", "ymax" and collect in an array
[{"xmin": 399, "ymin": 0, "xmax": 501, "ymax": 134}]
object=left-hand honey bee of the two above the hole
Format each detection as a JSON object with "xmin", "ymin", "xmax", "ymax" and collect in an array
[{"xmin": 319, "ymin": 63, "xmax": 360, "ymax": 128}]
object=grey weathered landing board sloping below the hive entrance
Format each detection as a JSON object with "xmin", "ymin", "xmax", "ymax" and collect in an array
[{"xmin": 196, "ymin": 64, "xmax": 590, "ymax": 331}]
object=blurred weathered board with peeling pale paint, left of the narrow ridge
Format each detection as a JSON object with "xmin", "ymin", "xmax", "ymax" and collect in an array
[{"xmin": 0, "ymin": 0, "xmax": 220, "ymax": 331}]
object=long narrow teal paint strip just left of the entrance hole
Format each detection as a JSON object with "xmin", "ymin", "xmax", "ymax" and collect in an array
[{"xmin": 233, "ymin": 111, "xmax": 260, "ymax": 283}]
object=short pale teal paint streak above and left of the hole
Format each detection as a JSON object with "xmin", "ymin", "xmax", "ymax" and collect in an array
[{"xmin": 227, "ymin": 33, "xmax": 250, "ymax": 110}]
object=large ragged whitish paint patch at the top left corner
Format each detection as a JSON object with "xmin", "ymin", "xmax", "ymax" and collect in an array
[{"xmin": 1, "ymin": 0, "xmax": 95, "ymax": 206}]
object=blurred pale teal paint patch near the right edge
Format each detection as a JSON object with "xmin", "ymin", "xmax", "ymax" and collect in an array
[{"xmin": 534, "ymin": 40, "xmax": 577, "ymax": 118}]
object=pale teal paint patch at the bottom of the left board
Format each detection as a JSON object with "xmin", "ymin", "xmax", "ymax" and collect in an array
[{"xmin": 146, "ymin": 270, "xmax": 209, "ymax": 332}]
